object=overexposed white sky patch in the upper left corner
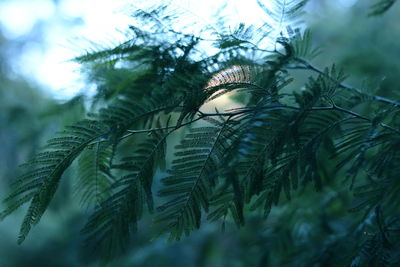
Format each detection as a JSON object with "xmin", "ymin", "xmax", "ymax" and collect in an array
[{"xmin": 0, "ymin": 0, "xmax": 131, "ymax": 100}]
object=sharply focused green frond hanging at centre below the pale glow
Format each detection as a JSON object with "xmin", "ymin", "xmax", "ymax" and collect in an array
[{"xmin": 155, "ymin": 117, "xmax": 233, "ymax": 241}]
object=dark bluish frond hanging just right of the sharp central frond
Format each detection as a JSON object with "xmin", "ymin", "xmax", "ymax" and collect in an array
[{"xmin": 208, "ymin": 105, "xmax": 285, "ymax": 220}]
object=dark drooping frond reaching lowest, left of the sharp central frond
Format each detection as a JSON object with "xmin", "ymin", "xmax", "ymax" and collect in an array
[{"xmin": 82, "ymin": 122, "xmax": 169, "ymax": 262}]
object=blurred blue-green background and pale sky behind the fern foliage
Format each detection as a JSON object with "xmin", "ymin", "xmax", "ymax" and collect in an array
[{"xmin": 0, "ymin": 0, "xmax": 400, "ymax": 267}]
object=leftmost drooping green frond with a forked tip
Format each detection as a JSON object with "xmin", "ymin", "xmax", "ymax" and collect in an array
[{"xmin": 2, "ymin": 120, "xmax": 109, "ymax": 243}]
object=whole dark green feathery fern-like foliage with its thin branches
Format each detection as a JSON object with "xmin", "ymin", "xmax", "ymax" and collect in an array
[{"xmin": 2, "ymin": 0, "xmax": 400, "ymax": 266}]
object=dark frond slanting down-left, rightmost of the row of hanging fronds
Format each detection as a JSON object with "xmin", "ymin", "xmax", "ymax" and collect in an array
[{"xmin": 252, "ymin": 112, "xmax": 351, "ymax": 215}]
